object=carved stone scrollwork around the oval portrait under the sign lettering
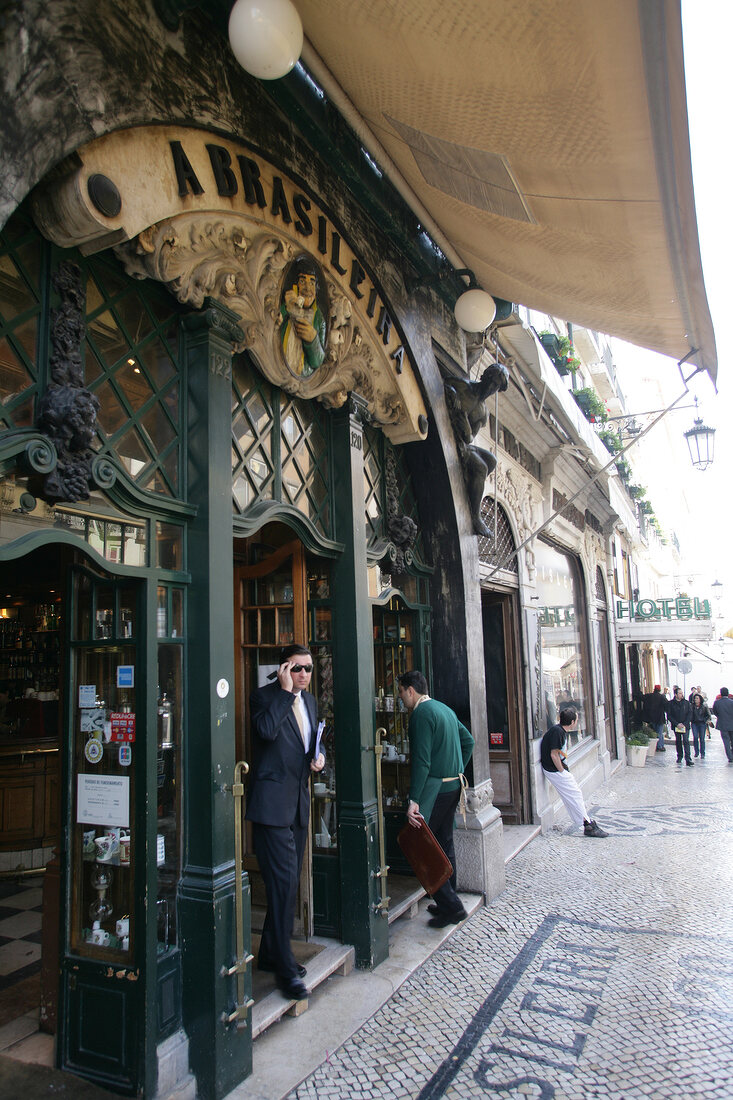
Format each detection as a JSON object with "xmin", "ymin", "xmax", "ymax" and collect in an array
[{"xmin": 114, "ymin": 213, "xmax": 406, "ymax": 425}]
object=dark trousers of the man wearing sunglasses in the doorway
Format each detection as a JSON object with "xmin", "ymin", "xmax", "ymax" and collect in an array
[{"xmin": 253, "ymin": 822, "xmax": 306, "ymax": 981}]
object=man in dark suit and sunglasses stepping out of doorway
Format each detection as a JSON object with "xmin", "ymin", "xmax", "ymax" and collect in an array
[{"xmin": 245, "ymin": 646, "xmax": 326, "ymax": 1001}]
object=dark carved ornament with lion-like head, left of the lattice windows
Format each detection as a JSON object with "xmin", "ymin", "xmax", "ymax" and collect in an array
[{"xmin": 34, "ymin": 261, "xmax": 99, "ymax": 502}]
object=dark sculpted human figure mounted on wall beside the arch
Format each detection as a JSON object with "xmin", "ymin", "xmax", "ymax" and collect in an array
[{"xmin": 445, "ymin": 363, "xmax": 508, "ymax": 536}]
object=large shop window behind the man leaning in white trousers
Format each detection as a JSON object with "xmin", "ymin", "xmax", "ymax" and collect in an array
[{"xmin": 535, "ymin": 539, "xmax": 592, "ymax": 745}]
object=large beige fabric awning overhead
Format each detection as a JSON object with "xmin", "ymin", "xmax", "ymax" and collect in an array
[{"xmin": 295, "ymin": 0, "xmax": 716, "ymax": 378}]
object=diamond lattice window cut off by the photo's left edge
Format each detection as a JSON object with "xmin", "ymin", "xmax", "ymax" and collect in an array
[{"xmin": 0, "ymin": 216, "xmax": 44, "ymax": 429}]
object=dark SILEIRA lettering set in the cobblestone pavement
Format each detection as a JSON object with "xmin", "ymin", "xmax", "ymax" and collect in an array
[{"xmin": 473, "ymin": 941, "xmax": 617, "ymax": 1100}]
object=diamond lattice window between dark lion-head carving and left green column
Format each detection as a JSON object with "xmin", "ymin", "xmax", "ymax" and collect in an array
[{"xmin": 85, "ymin": 257, "xmax": 183, "ymax": 496}]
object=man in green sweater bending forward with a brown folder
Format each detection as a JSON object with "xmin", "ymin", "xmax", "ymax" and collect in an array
[{"xmin": 400, "ymin": 671, "xmax": 473, "ymax": 928}]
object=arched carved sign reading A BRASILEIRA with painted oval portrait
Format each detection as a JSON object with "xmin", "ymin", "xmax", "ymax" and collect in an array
[{"xmin": 33, "ymin": 127, "xmax": 427, "ymax": 443}]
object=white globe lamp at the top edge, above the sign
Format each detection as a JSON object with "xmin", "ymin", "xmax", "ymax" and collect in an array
[{"xmin": 229, "ymin": 0, "xmax": 303, "ymax": 80}]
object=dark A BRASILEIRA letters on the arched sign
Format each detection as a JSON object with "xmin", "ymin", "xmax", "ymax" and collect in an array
[{"xmin": 169, "ymin": 141, "xmax": 405, "ymax": 374}]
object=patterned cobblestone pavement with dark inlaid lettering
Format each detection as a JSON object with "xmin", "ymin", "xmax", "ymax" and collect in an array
[{"xmin": 289, "ymin": 735, "xmax": 733, "ymax": 1100}]
